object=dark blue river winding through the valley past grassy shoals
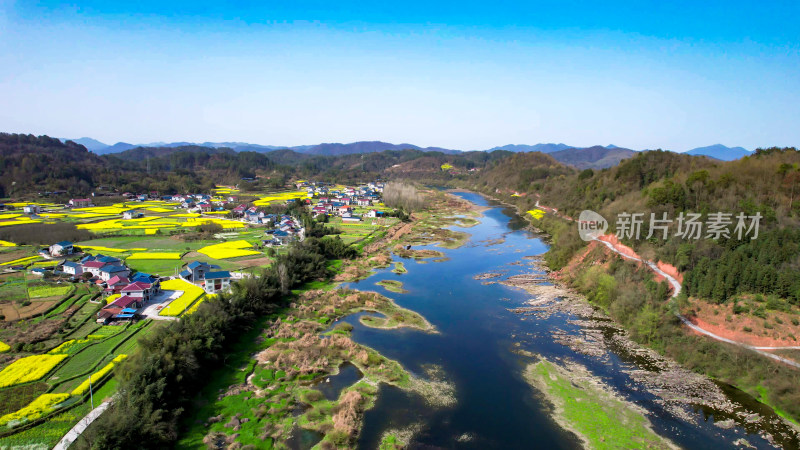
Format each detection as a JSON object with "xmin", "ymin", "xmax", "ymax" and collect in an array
[{"xmin": 343, "ymin": 193, "xmax": 797, "ymax": 449}]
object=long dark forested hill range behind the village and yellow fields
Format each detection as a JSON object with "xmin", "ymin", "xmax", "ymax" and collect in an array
[{"xmin": 0, "ymin": 134, "xmax": 511, "ymax": 198}]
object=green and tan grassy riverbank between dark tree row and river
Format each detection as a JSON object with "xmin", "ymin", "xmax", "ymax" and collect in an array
[{"xmin": 172, "ymin": 290, "xmax": 438, "ymax": 448}]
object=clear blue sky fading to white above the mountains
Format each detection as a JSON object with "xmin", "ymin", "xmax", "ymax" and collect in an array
[{"xmin": 0, "ymin": 0, "xmax": 800, "ymax": 151}]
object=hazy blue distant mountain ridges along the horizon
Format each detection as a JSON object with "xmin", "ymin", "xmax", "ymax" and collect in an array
[{"xmin": 62, "ymin": 137, "xmax": 751, "ymax": 169}]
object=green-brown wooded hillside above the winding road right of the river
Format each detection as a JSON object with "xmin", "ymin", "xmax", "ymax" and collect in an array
[{"xmin": 467, "ymin": 148, "xmax": 800, "ymax": 305}]
